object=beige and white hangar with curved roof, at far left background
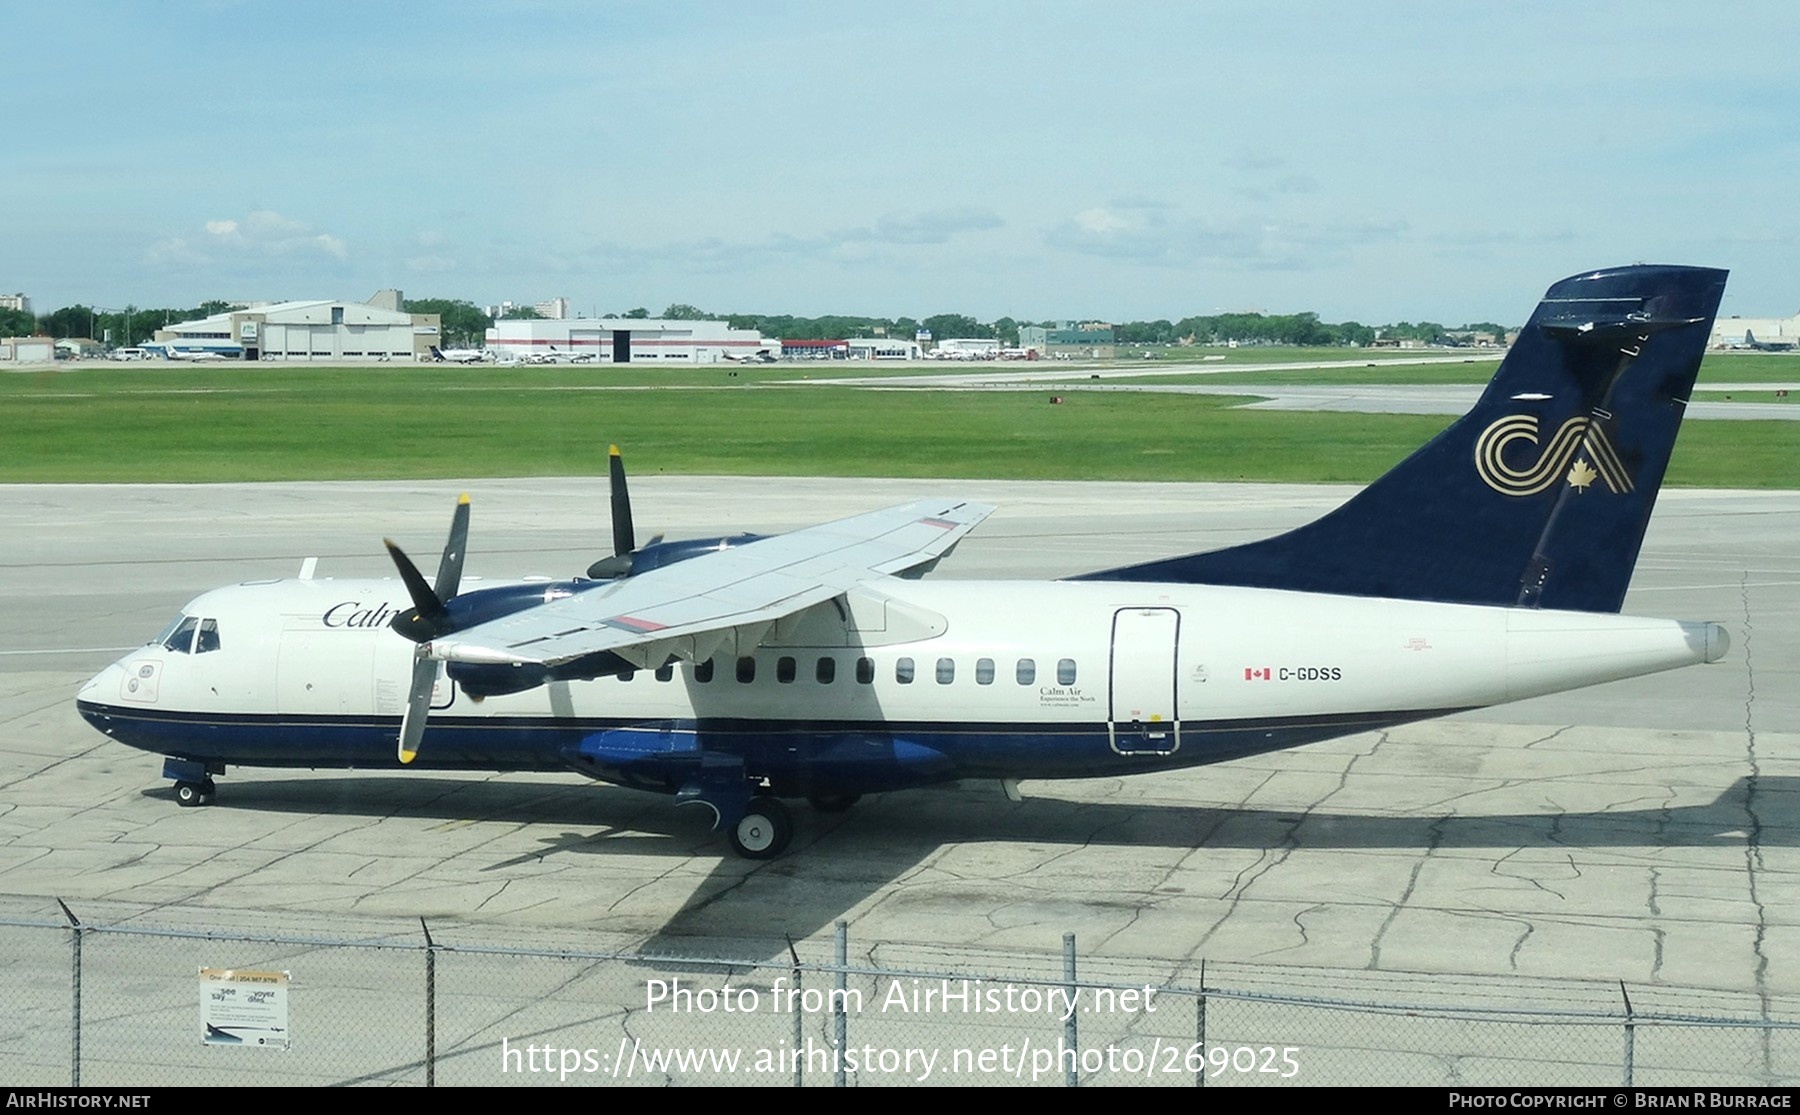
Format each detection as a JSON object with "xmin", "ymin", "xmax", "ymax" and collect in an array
[{"xmin": 142, "ymin": 290, "xmax": 441, "ymax": 360}]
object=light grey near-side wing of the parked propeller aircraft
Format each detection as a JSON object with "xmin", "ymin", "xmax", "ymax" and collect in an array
[{"xmin": 428, "ymin": 499, "xmax": 994, "ymax": 666}]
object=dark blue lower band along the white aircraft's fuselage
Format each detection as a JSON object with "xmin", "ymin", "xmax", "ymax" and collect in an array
[{"xmin": 77, "ymin": 703, "xmax": 1458, "ymax": 793}]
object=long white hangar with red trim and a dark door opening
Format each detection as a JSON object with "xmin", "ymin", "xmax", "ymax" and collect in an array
[{"xmin": 486, "ymin": 317, "xmax": 781, "ymax": 366}]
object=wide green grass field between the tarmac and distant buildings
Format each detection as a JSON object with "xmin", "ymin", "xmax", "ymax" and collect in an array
[{"xmin": 0, "ymin": 366, "xmax": 1800, "ymax": 488}]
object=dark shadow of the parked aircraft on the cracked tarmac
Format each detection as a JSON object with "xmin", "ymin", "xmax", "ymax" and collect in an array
[{"xmin": 162, "ymin": 776, "xmax": 1800, "ymax": 953}]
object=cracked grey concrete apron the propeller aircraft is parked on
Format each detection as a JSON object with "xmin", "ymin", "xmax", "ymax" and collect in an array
[{"xmin": 0, "ymin": 477, "xmax": 1800, "ymax": 1002}]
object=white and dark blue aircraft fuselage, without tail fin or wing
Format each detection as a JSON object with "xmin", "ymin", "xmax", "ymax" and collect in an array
[{"xmin": 77, "ymin": 580, "xmax": 1726, "ymax": 796}]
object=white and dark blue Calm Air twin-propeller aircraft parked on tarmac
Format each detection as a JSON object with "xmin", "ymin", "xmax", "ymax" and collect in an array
[{"xmin": 77, "ymin": 267, "xmax": 1726, "ymax": 857}]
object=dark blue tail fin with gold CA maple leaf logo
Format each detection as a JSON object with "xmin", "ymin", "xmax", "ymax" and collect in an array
[{"xmin": 1078, "ymin": 267, "xmax": 1726, "ymax": 612}]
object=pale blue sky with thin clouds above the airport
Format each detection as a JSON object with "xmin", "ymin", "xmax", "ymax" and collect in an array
[{"xmin": 14, "ymin": 0, "xmax": 1800, "ymax": 324}]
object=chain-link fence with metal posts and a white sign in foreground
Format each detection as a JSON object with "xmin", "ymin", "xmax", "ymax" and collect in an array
[{"xmin": 0, "ymin": 908, "xmax": 1800, "ymax": 1088}]
